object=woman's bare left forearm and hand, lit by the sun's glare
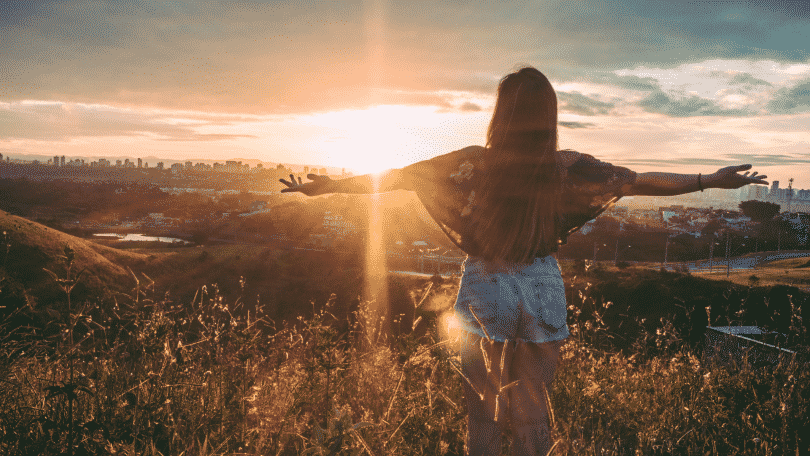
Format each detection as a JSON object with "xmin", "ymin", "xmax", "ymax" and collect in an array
[{"xmin": 279, "ymin": 169, "xmax": 411, "ymax": 196}]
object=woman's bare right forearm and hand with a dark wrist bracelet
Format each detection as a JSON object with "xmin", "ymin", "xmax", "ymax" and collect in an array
[{"xmin": 625, "ymin": 165, "xmax": 768, "ymax": 196}]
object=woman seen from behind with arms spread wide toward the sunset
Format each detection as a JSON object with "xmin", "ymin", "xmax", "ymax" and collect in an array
[{"xmin": 281, "ymin": 67, "xmax": 767, "ymax": 455}]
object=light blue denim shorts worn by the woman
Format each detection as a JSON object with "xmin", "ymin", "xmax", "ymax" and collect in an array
[{"xmin": 454, "ymin": 255, "xmax": 569, "ymax": 342}]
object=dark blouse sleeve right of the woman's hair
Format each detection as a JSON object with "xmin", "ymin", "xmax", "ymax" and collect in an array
[{"xmin": 561, "ymin": 152, "xmax": 636, "ymax": 243}]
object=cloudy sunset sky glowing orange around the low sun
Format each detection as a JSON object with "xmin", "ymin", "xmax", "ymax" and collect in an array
[{"xmin": 0, "ymin": 0, "xmax": 810, "ymax": 188}]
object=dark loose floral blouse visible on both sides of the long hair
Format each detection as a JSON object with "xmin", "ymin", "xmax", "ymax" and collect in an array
[{"xmin": 403, "ymin": 146, "xmax": 636, "ymax": 254}]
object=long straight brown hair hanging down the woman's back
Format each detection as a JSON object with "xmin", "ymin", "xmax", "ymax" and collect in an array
[{"xmin": 472, "ymin": 67, "xmax": 561, "ymax": 263}]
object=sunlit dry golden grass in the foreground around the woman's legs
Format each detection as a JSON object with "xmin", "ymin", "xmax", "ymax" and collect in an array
[{"xmin": 0, "ymin": 251, "xmax": 810, "ymax": 455}]
